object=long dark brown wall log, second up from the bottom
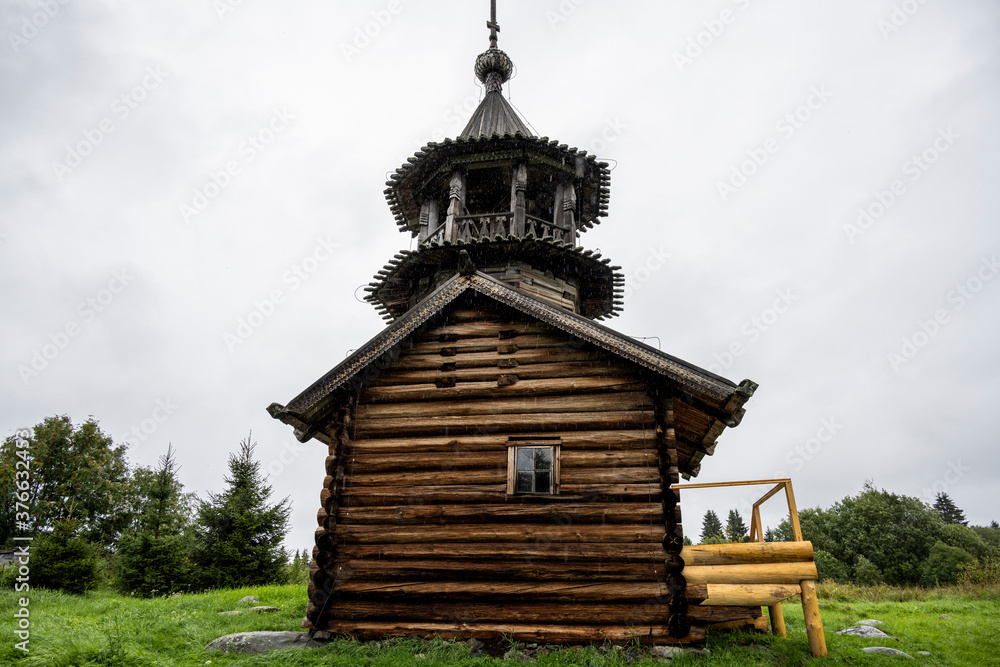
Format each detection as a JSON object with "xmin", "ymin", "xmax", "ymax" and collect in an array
[{"xmin": 326, "ymin": 598, "xmax": 670, "ymax": 626}]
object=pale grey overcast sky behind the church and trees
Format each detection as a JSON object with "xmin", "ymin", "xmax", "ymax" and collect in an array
[{"xmin": 0, "ymin": 0, "xmax": 1000, "ymax": 548}]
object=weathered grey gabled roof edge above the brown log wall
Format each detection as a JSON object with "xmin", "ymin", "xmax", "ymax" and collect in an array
[{"xmin": 268, "ymin": 273, "xmax": 757, "ymax": 432}]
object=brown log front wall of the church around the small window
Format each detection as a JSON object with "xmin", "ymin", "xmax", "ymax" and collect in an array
[{"xmin": 305, "ymin": 306, "xmax": 707, "ymax": 643}]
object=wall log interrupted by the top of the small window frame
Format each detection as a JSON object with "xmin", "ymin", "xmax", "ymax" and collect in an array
[{"xmin": 345, "ymin": 428, "xmax": 656, "ymax": 456}]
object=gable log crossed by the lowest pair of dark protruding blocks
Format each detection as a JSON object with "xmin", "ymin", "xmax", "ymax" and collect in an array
[{"xmin": 365, "ymin": 359, "xmax": 638, "ymax": 386}]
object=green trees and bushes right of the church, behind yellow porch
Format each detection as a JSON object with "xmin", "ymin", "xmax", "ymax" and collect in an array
[{"xmin": 701, "ymin": 481, "xmax": 1000, "ymax": 586}]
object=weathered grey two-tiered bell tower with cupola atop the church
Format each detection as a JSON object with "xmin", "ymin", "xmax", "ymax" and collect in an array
[{"xmin": 367, "ymin": 10, "xmax": 624, "ymax": 320}]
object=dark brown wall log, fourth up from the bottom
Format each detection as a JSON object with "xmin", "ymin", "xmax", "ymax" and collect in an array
[{"xmin": 337, "ymin": 559, "xmax": 665, "ymax": 582}]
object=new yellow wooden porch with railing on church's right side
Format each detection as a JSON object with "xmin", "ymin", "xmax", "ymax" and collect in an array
[{"xmin": 671, "ymin": 479, "xmax": 827, "ymax": 657}]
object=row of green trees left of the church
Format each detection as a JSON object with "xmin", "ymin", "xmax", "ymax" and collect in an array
[{"xmin": 0, "ymin": 416, "xmax": 308, "ymax": 597}]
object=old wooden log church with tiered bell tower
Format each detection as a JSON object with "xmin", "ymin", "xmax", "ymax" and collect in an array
[{"xmin": 268, "ymin": 2, "xmax": 822, "ymax": 652}]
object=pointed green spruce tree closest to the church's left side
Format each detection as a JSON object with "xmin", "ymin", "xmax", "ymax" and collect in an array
[{"xmin": 193, "ymin": 438, "xmax": 291, "ymax": 588}]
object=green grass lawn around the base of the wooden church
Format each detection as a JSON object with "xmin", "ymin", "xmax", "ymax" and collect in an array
[{"xmin": 0, "ymin": 584, "xmax": 1000, "ymax": 667}]
